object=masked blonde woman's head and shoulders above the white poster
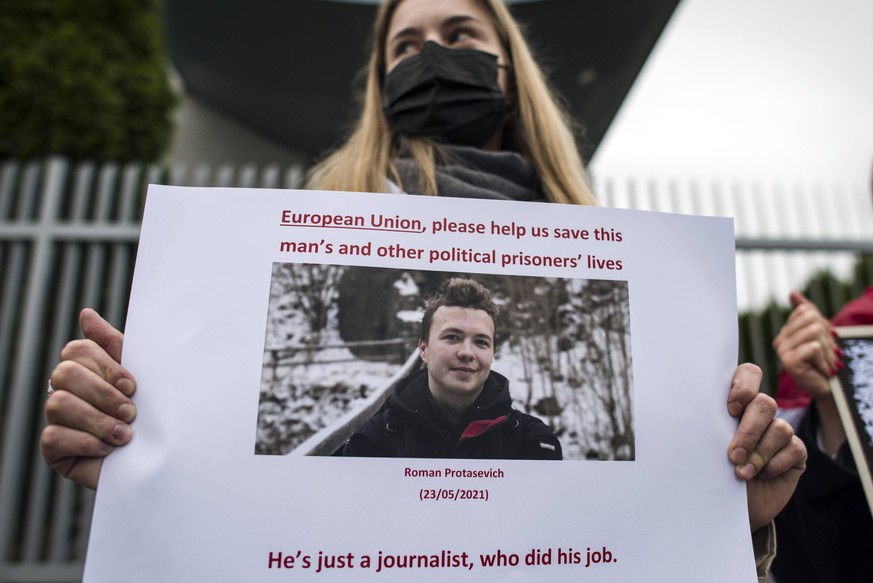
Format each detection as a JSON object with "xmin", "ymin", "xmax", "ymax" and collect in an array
[{"xmin": 310, "ymin": 0, "xmax": 595, "ymax": 204}]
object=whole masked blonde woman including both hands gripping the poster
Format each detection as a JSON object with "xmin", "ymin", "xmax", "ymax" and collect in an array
[{"xmin": 41, "ymin": 0, "xmax": 806, "ymax": 572}]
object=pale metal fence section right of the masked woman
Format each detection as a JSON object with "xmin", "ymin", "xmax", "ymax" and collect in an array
[{"xmin": 599, "ymin": 178, "xmax": 873, "ymax": 386}]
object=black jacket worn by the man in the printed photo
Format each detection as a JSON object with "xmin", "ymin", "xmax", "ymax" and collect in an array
[{"xmin": 344, "ymin": 370, "xmax": 561, "ymax": 460}]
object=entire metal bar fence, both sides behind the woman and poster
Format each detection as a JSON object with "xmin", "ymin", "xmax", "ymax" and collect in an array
[{"xmin": 0, "ymin": 159, "xmax": 873, "ymax": 582}]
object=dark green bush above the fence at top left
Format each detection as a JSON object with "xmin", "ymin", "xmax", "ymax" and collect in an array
[{"xmin": 0, "ymin": 0, "xmax": 178, "ymax": 161}]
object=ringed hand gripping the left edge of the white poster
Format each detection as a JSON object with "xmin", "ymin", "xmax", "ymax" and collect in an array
[{"xmin": 39, "ymin": 309, "xmax": 136, "ymax": 489}]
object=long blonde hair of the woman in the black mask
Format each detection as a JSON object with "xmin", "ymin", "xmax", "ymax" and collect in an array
[{"xmin": 308, "ymin": 0, "xmax": 596, "ymax": 205}]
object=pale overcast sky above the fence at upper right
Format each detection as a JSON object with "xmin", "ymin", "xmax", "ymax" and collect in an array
[{"xmin": 590, "ymin": 0, "xmax": 873, "ymax": 190}]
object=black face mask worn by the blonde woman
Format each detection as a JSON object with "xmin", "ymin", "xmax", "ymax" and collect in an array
[{"xmin": 382, "ymin": 41, "xmax": 506, "ymax": 147}]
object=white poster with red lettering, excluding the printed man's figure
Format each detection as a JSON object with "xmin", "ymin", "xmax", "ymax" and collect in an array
[{"xmin": 85, "ymin": 186, "xmax": 755, "ymax": 583}]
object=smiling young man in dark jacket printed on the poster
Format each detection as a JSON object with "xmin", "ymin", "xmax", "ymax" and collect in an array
[{"xmin": 345, "ymin": 279, "xmax": 561, "ymax": 460}]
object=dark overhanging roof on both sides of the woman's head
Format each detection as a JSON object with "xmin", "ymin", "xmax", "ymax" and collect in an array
[{"xmin": 164, "ymin": 0, "xmax": 679, "ymax": 162}]
